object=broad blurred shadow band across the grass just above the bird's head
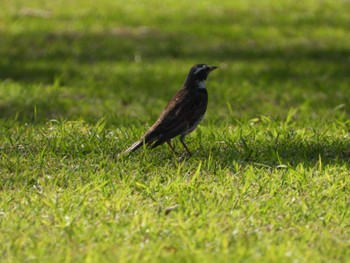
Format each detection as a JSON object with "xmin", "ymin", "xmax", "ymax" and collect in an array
[{"xmin": 0, "ymin": 31, "xmax": 350, "ymax": 83}]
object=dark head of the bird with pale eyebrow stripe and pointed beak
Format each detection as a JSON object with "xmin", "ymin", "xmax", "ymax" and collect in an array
[{"xmin": 185, "ymin": 64, "xmax": 218, "ymax": 88}]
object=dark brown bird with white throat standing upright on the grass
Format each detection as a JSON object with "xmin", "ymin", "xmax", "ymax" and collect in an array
[{"xmin": 124, "ymin": 64, "xmax": 218, "ymax": 156}]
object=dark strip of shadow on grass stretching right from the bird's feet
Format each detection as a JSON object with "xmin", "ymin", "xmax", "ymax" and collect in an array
[{"xmin": 194, "ymin": 137, "xmax": 350, "ymax": 168}]
